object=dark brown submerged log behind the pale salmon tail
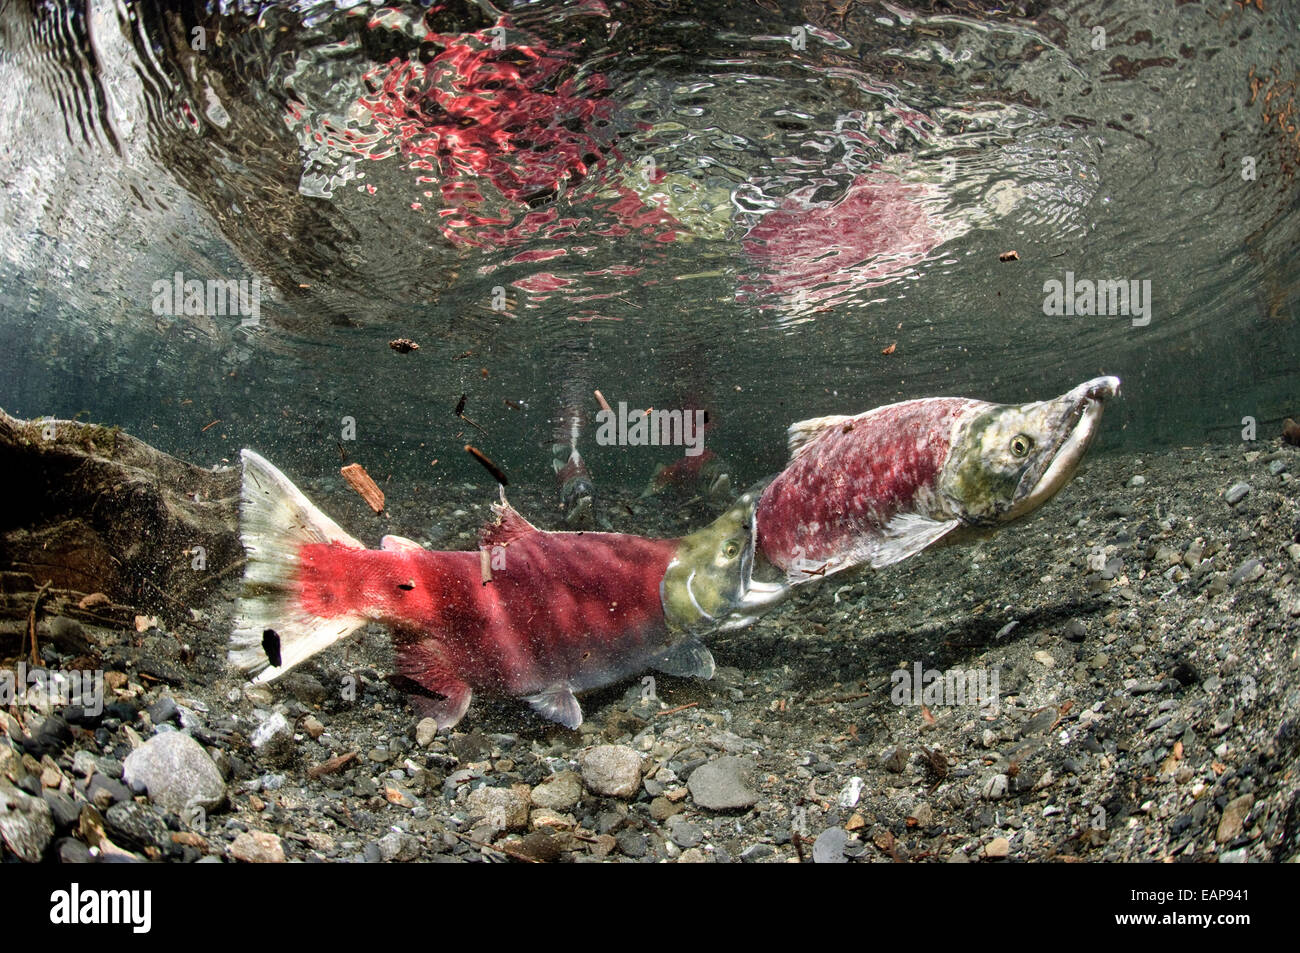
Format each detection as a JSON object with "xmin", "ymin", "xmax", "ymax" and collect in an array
[{"xmin": 0, "ymin": 411, "xmax": 243, "ymax": 620}]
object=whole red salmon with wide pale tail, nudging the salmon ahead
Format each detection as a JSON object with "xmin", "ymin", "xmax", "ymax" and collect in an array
[{"xmin": 231, "ymin": 450, "xmax": 757, "ymax": 727}]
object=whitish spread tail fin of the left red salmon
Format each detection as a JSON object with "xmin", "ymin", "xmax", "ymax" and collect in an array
[{"xmin": 229, "ymin": 450, "xmax": 368, "ymax": 681}]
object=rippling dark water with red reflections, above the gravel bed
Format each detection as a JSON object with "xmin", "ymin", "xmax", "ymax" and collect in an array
[{"xmin": 0, "ymin": 0, "xmax": 1300, "ymax": 484}]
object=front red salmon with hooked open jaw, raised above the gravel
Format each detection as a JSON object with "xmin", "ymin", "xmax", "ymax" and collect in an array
[{"xmin": 757, "ymin": 377, "xmax": 1119, "ymax": 584}]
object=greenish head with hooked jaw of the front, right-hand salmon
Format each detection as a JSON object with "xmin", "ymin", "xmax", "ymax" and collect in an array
[{"xmin": 939, "ymin": 377, "xmax": 1119, "ymax": 527}]
